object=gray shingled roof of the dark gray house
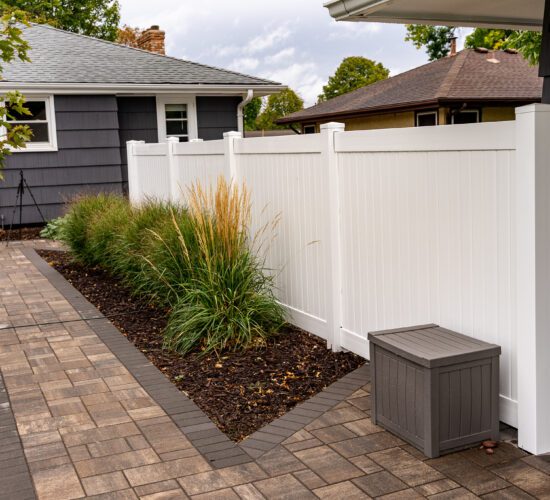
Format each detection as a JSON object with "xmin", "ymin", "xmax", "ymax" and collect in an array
[{"xmin": 2, "ymin": 24, "xmax": 278, "ymax": 86}]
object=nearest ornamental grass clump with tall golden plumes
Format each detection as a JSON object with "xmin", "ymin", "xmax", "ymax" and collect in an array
[{"xmin": 165, "ymin": 179, "xmax": 284, "ymax": 353}]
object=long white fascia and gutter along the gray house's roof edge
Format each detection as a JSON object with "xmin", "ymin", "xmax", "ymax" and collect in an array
[{"xmin": 0, "ymin": 82, "xmax": 287, "ymax": 96}]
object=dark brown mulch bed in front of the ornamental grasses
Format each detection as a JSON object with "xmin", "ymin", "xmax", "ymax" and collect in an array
[{"xmin": 39, "ymin": 251, "xmax": 364, "ymax": 441}]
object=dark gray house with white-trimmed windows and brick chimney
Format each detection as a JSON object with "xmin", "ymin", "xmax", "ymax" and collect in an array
[{"xmin": 0, "ymin": 25, "xmax": 284, "ymax": 224}]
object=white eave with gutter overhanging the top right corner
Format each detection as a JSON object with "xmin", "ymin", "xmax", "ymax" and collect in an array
[{"xmin": 325, "ymin": 0, "xmax": 542, "ymax": 31}]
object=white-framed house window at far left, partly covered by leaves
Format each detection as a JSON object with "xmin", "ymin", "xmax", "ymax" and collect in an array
[{"xmin": 6, "ymin": 96, "xmax": 57, "ymax": 152}]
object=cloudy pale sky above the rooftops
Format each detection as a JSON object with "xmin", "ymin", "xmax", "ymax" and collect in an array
[{"xmin": 120, "ymin": 0, "xmax": 470, "ymax": 106}]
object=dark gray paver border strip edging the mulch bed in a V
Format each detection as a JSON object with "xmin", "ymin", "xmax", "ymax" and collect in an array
[{"xmin": 20, "ymin": 247, "xmax": 370, "ymax": 468}]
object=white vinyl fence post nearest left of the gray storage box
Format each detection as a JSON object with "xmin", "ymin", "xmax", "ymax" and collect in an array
[{"xmin": 321, "ymin": 122, "xmax": 345, "ymax": 351}]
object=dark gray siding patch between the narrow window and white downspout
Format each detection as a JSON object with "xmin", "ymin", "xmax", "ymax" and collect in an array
[{"xmin": 197, "ymin": 96, "xmax": 242, "ymax": 141}]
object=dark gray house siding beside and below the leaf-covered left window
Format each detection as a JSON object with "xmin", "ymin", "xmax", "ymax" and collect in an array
[{"xmin": 0, "ymin": 96, "xmax": 122, "ymax": 224}]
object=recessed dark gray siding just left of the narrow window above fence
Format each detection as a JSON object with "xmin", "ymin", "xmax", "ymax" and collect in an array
[{"xmin": 117, "ymin": 97, "xmax": 158, "ymax": 190}]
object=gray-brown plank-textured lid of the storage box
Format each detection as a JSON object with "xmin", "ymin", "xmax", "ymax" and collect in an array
[{"xmin": 368, "ymin": 324, "xmax": 500, "ymax": 368}]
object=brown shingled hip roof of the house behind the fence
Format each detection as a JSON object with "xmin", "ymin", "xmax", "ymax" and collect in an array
[{"xmin": 279, "ymin": 49, "xmax": 542, "ymax": 123}]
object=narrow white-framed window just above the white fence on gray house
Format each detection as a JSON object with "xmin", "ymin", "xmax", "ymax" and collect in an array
[{"xmin": 157, "ymin": 96, "xmax": 198, "ymax": 142}]
